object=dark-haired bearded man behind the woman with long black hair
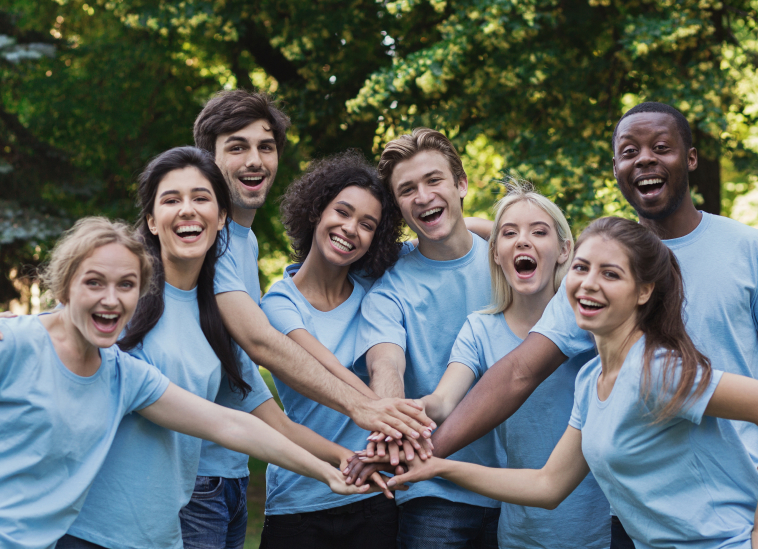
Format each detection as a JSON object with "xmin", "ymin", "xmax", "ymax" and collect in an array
[{"xmin": 181, "ymin": 90, "xmax": 431, "ymax": 549}]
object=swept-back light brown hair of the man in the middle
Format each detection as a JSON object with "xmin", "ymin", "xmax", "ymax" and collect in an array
[{"xmin": 378, "ymin": 128, "xmax": 466, "ymax": 196}]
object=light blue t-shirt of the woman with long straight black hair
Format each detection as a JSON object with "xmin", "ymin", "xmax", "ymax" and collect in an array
[{"xmin": 69, "ymin": 284, "xmax": 222, "ymax": 549}]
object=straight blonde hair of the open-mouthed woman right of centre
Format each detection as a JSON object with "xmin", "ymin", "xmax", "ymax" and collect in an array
[{"xmin": 481, "ymin": 181, "xmax": 574, "ymax": 314}]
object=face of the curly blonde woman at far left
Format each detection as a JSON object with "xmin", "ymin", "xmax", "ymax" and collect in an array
[{"xmin": 64, "ymin": 244, "xmax": 140, "ymax": 347}]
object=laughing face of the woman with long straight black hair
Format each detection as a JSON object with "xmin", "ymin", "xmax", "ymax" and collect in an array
[{"xmin": 147, "ymin": 167, "xmax": 226, "ymax": 265}]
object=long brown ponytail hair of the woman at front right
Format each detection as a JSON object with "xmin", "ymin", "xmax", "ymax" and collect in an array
[{"xmin": 576, "ymin": 217, "xmax": 711, "ymax": 423}]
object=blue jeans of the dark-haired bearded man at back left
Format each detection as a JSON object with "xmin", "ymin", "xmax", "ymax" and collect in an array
[{"xmin": 179, "ymin": 477, "xmax": 250, "ymax": 549}]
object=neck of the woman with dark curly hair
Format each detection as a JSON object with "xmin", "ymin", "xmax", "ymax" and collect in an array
[{"xmin": 292, "ymin": 249, "xmax": 353, "ymax": 311}]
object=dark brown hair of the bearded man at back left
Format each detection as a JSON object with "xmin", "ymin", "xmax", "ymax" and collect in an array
[{"xmin": 193, "ymin": 90, "xmax": 290, "ymax": 158}]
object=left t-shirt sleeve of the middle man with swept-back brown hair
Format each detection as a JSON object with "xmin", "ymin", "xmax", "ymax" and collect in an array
[{"xmin": 355, "ymin": 282, "xmax": 407, "ymax": 360}]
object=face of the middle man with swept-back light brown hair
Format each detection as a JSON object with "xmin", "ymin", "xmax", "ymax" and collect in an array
[{"xmin": 390, "ymin": 151, "xmax": 468, "ymax": 241}]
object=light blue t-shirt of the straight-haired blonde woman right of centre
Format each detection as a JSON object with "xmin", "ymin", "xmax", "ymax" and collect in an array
[{"xmin": 450, "ymin": 313, "xmax": 611, "ymax": 549}]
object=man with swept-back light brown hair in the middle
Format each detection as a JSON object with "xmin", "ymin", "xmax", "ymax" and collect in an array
[{"xmin": 356, "ymin": 128, "xmax": 505, "ymax": 549}]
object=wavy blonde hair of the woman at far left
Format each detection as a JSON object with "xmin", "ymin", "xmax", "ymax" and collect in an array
[{"xmin": 40, "ymin": 217, "xmax": 153, "ymax": 304}]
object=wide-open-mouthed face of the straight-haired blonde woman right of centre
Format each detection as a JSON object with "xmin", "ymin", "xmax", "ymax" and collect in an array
[{"xmin": 494, "ymin": 200, "xmax": 569, "ymax": 295}]
